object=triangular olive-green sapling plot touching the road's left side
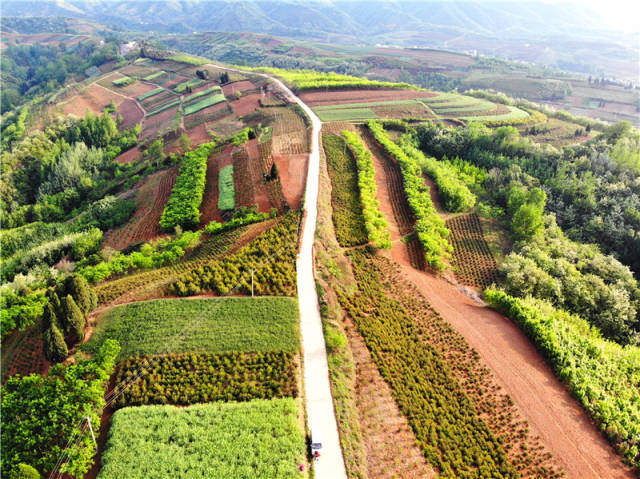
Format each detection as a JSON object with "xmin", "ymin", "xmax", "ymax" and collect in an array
[{"xmin": 169, "ymin": 212, "xmax": 300, "ymax": 296}]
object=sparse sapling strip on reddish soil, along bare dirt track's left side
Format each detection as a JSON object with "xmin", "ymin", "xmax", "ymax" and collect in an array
[{"xmin": 369, "ymin": 256, "xmax": 561, "ymax": 478}]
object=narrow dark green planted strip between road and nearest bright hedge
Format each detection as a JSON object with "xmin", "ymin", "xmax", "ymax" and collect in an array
[{"xmin": 322, "ymin": 133, "xmax": 368, "ymax": 247}]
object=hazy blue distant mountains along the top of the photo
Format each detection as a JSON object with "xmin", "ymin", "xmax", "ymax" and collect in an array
[{"xmin": 2, "ymin": 0, "xmax": 638, "ymax": 81}]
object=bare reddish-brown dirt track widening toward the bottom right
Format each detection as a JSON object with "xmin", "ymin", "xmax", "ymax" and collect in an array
[{"xmin": 365, "ymin": 136, "xmax": 634, "ymax": 479}]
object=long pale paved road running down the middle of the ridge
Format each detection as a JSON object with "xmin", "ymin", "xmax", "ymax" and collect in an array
[{"xmin": 212, "ymin": 65, "xmax": 347, "ymax": 479}]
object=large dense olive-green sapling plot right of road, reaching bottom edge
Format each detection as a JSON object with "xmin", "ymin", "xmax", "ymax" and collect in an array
[{"xmin": 339, "ymin": 250, "xmax": 519, "ymax": 478}]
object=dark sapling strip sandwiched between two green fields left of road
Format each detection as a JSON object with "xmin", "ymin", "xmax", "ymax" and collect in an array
[{"xmin": 115, "ymin": 351, "xmax": 298, "ymax": 408}]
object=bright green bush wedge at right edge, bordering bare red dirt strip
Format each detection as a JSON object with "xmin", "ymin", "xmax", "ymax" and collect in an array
[{"xmin": 484, "ymin": 289, "xmax": 640, "ymax": 468}]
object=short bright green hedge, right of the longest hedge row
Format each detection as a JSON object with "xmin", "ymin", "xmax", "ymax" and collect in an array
[{"xmin": 400, "ymin": 136, "xmax": 476, "ymax": 213}]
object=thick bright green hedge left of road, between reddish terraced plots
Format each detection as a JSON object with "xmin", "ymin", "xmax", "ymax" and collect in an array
[{"xmin": 160, "ymin": 142, "xmax": 216, "ymax": 231}]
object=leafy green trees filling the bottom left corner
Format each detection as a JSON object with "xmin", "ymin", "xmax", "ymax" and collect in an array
[{"xmin": 0, "ymin": 341, "xmax": 119, "ymax": 478}]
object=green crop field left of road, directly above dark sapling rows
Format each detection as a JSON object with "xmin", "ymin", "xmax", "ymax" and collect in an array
[{"xmin": 81, "ymin": 297, "xmax": 300, "ymax": 360}]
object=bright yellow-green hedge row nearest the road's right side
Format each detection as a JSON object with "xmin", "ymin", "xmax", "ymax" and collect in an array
[{"xmin": 342, "ymin": 130, "xmax": 391, "ymax": 248}]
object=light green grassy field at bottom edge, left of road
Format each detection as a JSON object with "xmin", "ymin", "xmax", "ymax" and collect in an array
[{"xmin": 98, "ymin": 398, "xmax": 307, "ymax": 479}]
